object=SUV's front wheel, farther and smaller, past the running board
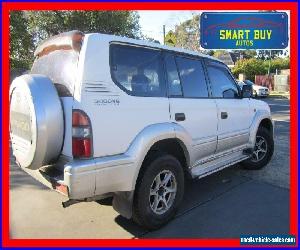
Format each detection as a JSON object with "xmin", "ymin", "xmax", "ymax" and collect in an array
[{"xmin": 241, "ymin": 127, "xmax": 274, "ymax": 170}]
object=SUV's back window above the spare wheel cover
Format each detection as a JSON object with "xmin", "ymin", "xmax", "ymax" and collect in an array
[{"xmin": 31, "ymin": 50, "xmax": 79, "ymax": 96}]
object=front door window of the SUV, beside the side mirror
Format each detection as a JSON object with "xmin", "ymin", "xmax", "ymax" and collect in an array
[{"xmin": 207, "ymin": 66, "xmax": 239, "ymax": 98}]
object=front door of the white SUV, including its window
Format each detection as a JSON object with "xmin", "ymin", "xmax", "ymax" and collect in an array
[{"xmin": 205, "ymin": 60, "xmax": 252, "ymax": 153}]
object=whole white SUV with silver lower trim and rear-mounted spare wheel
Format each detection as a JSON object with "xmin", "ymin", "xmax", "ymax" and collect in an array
[{"xmin": 10, "ymin": 31, "xmax": 274, "ymax": 229}]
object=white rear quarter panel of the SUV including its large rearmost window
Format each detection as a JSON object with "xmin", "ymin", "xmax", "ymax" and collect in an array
[{"xmin": 80, "ymin": 41, "xmax": 170, "ymax": 157}]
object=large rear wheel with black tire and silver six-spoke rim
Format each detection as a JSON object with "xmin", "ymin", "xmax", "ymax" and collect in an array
[{"xmin": 133, "ymin": 154, "xmax": 184, "ymax": 230}]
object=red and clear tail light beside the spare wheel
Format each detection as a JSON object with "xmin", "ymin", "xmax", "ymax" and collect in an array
[{"xmin": 72, "ymin": 110, "xmax": 92, "ymax": 158}]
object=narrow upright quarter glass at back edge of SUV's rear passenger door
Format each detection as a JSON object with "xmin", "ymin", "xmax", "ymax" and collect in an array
[{"xmin": 165, "ymin": 55, "xmax": 182, "ymax": 96}]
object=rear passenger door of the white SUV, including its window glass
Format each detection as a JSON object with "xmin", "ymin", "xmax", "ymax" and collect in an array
[{"xmin": 164, "ymin": 53, "xmax": 218, "ymax": 165}]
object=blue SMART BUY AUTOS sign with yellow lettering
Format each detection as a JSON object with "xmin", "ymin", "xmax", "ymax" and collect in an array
[{"xmin": 200, "ymin": 12, "xmax": 288, "ymax": 49}]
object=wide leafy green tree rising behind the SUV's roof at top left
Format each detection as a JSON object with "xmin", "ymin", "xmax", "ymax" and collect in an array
[{"xmin": 26, "ymin": 11, "xmax": 140, "ymax": 39}]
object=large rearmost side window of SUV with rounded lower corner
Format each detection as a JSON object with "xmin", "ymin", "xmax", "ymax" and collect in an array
[{"xmin": 110, "ymin": 45, "xmax": 166, "ymax": 97}]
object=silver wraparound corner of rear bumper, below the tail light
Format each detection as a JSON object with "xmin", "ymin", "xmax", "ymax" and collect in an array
[{"xmin": 64, "ymin": 154, "xmax": 136, "ymax": 199}]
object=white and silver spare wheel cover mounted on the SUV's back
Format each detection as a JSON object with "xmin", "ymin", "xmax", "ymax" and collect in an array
[{"xmin": 9, "ymin": 75, "xmax": 64, "ymax": 170}]
